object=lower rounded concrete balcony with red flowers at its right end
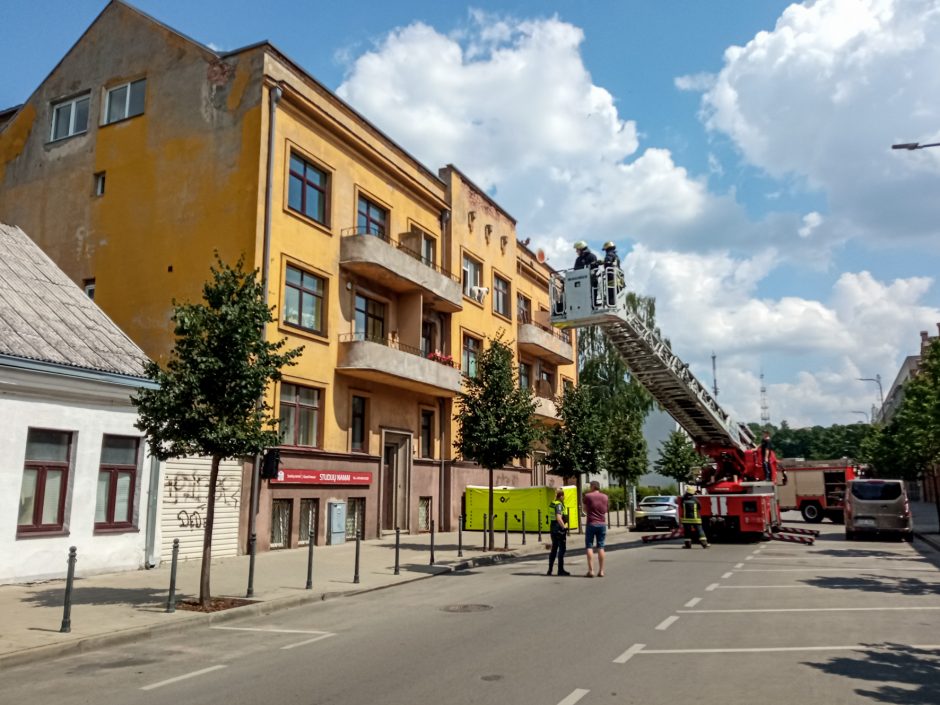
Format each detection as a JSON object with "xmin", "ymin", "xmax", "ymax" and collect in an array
[{"xmin": 336, "ymin": 333, "xmax": 462, "ymax": 397}]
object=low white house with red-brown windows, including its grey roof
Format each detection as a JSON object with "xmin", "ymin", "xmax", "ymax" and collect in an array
[{"xmin": 0, "ymin": 224, "xmax": 161, "ymax": 583}]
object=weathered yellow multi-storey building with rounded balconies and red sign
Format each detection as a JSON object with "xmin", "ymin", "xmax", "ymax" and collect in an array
[{"xmin": 0, "ymin": 0, "xmax": 575, "ymax": 549}]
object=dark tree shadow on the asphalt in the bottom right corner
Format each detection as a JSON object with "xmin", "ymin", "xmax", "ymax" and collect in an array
[{"xmin": 804, "ymin": 643, "xmax": 940, "ymax": 705}]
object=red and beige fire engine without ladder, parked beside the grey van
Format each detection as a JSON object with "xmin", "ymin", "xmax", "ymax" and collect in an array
[{"xmin": 777, "ymin": 458, "xmax": 859, "ymax": 524}]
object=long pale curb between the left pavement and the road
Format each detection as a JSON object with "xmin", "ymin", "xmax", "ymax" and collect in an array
[{"xmin": 0, "ymin": 544, "xmax": 544, "ymax": 669}]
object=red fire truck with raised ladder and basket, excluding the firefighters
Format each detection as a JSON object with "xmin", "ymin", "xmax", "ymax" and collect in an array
[{"xmin": 549, "ymin": 267, "xmax": 780, "ymax": 540}]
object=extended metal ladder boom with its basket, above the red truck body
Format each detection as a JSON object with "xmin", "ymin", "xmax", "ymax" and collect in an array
[{"xmin": 551, "ymin": 267, "xmax": 755, "ymax": 452}]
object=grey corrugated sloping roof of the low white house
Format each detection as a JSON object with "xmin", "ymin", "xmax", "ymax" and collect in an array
[{"xmin": 0, "ymin": 223, "xmax": 147, "ymax": 377}]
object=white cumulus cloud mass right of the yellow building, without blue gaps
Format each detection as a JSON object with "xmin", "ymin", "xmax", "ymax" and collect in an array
[{"xmin": 338, "ymin": 0, "xmax": 940, "ymax": 425}]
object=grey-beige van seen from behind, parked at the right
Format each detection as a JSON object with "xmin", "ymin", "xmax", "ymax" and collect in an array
[{"xmin": 845, "ymin": 479, "xmax": 914, "ymax": 541}]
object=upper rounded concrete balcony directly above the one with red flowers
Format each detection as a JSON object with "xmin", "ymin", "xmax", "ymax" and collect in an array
[{"xmin": 339, "ymin": 228, "xmax": 463, "ymax": 313}]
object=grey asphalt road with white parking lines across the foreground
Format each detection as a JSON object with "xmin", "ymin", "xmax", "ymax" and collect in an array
[{"xmin": 7, "ymin": 523, "xmax": 940, "ymax": 705}]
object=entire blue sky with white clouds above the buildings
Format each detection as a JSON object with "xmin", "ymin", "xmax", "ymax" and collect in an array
[{"xmin": 0, "ymin": 0, "xmax": 940, "ymax": 426}]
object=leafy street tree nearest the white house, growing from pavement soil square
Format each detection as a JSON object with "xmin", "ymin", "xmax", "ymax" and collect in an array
[{"xmin": 133, "ymin": 253, "xmax": 302, "ymax": 608}]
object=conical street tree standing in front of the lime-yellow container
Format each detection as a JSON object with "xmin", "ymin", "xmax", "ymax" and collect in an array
[{"xmin": 454, "ymin": 332, "xmax": 541, "ymax": 551}]
